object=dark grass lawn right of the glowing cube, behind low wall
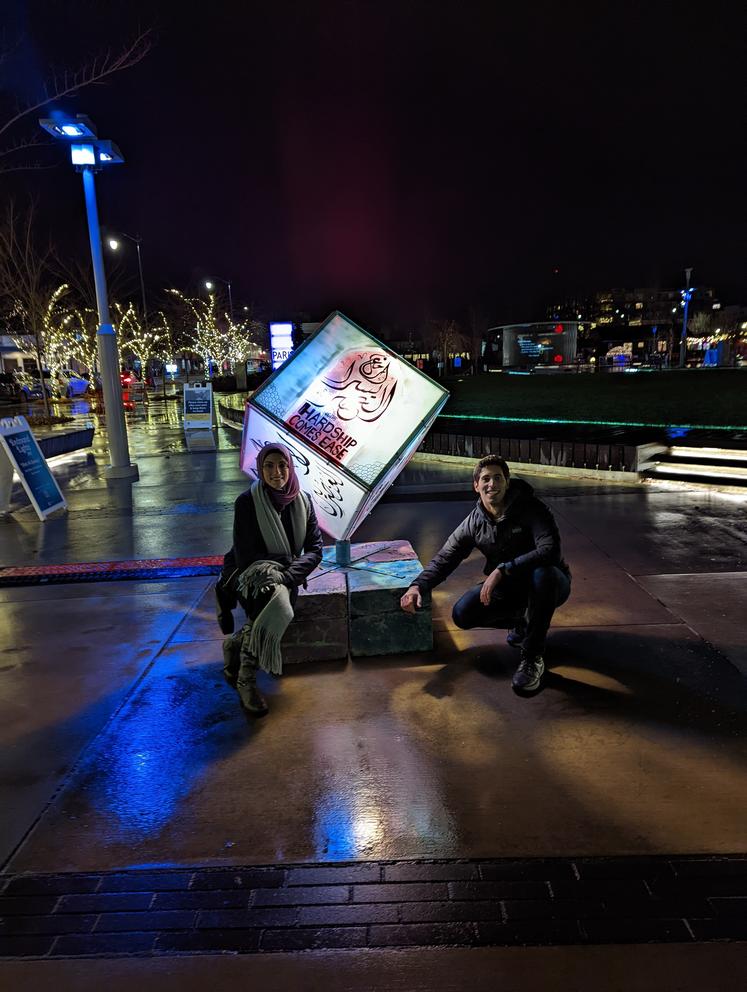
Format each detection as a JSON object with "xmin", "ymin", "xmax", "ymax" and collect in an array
[{"xmin": 442, "ymin": 369, "xmax": 747, "ymax": 427}]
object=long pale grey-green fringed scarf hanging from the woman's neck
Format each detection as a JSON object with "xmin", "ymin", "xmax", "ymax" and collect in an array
[{"xmin": 237, "ymin": 482, "xmax": 309, "ymax": 675}]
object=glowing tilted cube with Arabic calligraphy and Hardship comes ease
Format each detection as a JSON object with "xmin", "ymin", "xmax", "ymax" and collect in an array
[{"xmin": 241, "ymin": 313, "xmax": 448, "ymax": 540}]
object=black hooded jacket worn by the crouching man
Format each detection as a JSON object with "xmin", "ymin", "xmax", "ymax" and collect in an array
[{"xmin": 413, "ymin": 479, "xmax": 570, "ymax": 592}]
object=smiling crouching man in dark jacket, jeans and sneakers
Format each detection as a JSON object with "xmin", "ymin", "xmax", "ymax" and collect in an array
[{"xmin": 400, "ymin": 455, "xmax": 571, "ymax": 694}]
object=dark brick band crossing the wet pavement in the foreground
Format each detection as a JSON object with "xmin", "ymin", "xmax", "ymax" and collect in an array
[{"xmin": 0, "ymin": 854, "xmax": 747, "ymax": 958}]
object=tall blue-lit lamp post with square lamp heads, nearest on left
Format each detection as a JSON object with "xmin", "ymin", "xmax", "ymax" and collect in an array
[{"xmin": 39, "ymin": 114, "xmax": 138, "ymax": 479}]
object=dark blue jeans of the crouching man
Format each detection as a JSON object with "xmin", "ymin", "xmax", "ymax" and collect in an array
[{"xmin": 452, "ymin": 565, "xmax": 571, "ymax": 655}]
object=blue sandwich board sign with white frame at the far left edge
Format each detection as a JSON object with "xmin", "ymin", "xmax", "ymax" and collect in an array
[{"xmin": 0, "ymin": 417, "xmax": 67, "ymax": 521}]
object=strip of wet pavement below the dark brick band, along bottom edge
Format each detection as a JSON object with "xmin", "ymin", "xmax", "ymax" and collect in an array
[{"xmin": 0, "ymin": 943, "xmax": 745, "ymax": 992}]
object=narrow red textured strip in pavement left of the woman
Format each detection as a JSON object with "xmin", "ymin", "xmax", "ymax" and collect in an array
[{"xmin": 0, "ymin": 555, "xmax": 223, "ymax": 587}]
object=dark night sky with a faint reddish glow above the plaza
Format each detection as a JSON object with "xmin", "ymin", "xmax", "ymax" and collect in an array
[{"xmin": 0, "ymin": 0, "xmax": 747, "ymax": 330}]
